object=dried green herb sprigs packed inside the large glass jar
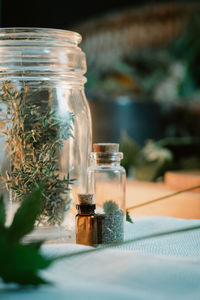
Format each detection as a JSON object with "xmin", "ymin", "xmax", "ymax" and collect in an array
[{"xmin": 0, "ymin": 83, "xmax": 74, "ymax": 225}]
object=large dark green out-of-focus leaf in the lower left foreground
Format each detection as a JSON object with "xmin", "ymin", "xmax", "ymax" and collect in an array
[{"xmin": 0, "ymin": 185, "xmax": 54, "ymax": 286}]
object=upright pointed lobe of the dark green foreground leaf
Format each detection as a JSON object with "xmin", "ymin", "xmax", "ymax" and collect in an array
[{"xmin": 8, "ymin": 186, "xmax": 43, "ymax": 243}]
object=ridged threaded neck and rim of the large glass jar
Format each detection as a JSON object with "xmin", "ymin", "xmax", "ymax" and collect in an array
[{"xmin": 0, "ymin": 28, "xmax": 86, "ymax": 85}]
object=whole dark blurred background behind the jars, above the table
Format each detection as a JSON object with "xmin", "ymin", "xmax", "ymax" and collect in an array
[{"xmin": 0, "ymin": 0, "xmax": 200, "ymax": 181}]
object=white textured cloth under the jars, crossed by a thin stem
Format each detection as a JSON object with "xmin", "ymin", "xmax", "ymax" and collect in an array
[{"xmin": 0, "ymin": 217, "xmax": 200, "ymax": 300}]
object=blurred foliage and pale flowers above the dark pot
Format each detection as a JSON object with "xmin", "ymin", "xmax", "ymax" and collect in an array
[{"xmin": 86, "ymin": 11, "xmax": 200, "ymax": 101}]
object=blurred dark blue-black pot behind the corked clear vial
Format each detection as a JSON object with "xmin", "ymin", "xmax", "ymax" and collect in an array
[{"xmin": 89, "ymin": 97, "xmax": 161, "ymax": 145}]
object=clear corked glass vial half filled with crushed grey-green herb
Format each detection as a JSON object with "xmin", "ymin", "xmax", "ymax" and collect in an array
[{"xmin": 87, "ymin": 143, "xmax": 126, "ymax": 244}]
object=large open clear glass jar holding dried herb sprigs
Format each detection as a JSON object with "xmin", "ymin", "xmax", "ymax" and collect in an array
[{"xmin": 0, "ymin": 28, "xmax": 91, "ymax": 243}]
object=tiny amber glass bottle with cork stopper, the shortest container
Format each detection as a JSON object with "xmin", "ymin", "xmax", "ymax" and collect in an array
[{"xmin": 76, "ymin": 194, "xmax": 97, "ymax": 246}]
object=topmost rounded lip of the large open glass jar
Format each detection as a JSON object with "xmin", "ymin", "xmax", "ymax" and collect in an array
[{"xmin": 0, "ymin": 27, "xmax": 82, "ymax": 45}]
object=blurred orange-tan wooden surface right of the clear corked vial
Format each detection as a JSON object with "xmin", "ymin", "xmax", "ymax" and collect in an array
[{"xmin": 126, "ymin": 180, "xmax": 200, "ymax": 219}]
